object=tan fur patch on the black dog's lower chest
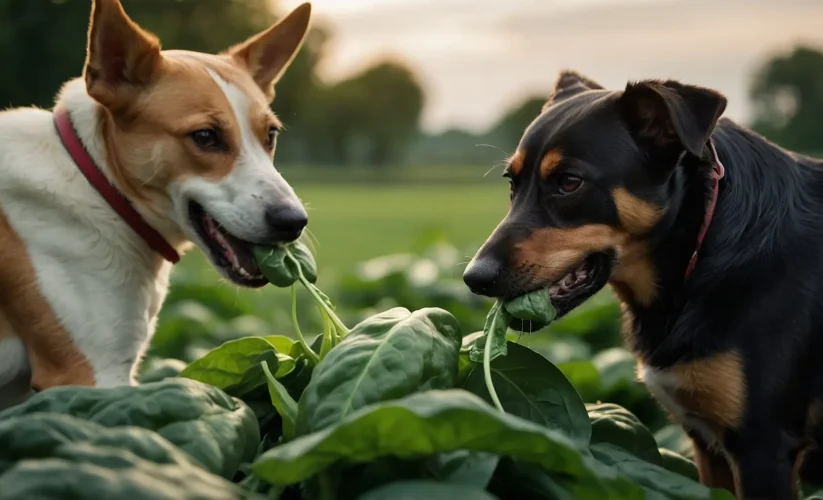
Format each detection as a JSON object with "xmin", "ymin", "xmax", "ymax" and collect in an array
[{"xmin": 666, "ymin": 351, "xmax": 746, "ymax": 429}]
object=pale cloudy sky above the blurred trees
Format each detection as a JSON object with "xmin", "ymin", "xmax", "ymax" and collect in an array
[{"xmin": 279, "ymin": 0, "xmax": 823, "ymax": 132}]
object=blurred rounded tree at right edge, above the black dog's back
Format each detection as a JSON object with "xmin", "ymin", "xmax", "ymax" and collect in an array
[{"xmin": 750, "ymin": 46, "xmax": 823, "ymax": 152}]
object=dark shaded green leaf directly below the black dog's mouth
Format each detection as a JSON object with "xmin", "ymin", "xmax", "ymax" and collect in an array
[{"xmin": 464, "ymin": 343, "xmax": 592, "ymax": 447}]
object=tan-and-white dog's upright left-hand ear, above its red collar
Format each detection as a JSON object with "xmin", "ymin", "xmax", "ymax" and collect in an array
[{"xmin": 83, "ymin": 0, "xmax": 162, "ymax": 107}]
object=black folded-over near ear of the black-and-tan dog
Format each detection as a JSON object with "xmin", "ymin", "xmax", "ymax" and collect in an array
[{"xmin": 618, "ymin": 80, "xmax": 727, "ymax": 157}]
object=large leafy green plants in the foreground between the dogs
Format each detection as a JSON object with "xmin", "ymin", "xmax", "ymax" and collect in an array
[{"xmin": 0, "ymin": 240, "xmax": 748, "ymax": 500}]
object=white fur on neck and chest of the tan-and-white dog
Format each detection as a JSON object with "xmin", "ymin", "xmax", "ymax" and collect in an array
[{"xmin": 0, "ymin": 79, "xmax": 171, "ymax": 387}]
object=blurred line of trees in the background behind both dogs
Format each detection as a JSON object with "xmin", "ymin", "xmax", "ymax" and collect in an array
[{"xmin": 0, "ymin": 0, "xmax": 823, "ymax": 168}]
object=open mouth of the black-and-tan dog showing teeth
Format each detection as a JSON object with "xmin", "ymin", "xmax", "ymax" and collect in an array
[{"xmin": 509, "ymin": 252, "xmax": 614, "ymax": 332}]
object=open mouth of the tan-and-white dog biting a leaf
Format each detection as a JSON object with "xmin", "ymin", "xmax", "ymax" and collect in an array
[{"xmin": 189, "ymin": 201, "xmax": 269, "ymax": 288}]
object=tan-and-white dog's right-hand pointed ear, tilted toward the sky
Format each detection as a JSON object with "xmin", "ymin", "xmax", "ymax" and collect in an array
[{"xmin": 226, "ymin": 3, "xmax": 311, "ymax": 98}]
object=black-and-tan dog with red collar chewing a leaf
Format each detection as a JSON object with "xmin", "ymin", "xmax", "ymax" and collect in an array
[{"xmin": 464, "ymin": 71, "xmax": 823, "ymax": 499}]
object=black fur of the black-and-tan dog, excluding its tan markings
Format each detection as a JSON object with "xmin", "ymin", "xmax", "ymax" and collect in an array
[{"xmin": 466, "ymin": 69, "xmax": 823, "ymax": 499}]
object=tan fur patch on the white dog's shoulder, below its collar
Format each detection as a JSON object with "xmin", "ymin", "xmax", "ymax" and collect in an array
[{"xmin": 0, "ymin": 205, "xmax": 94, "ymax": 389}]
